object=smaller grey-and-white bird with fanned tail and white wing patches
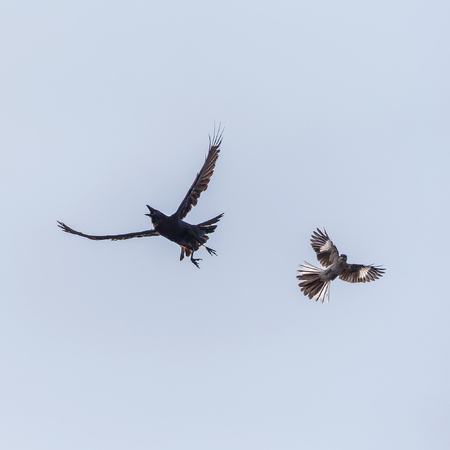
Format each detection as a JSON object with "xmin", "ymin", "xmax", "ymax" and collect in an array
[{"xmin": 297, "ymin": 228, "xmax": 386, "ymax": 303}]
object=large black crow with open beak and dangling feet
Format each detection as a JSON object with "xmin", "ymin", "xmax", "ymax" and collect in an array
[{"xmin": 58, "ymin": 125, "xmax": 223, "ymax": 268}]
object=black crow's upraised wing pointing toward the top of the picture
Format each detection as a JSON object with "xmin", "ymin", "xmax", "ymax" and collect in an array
[{"xmin": 177, "ymin": 125, "xmax": 223, "ymax": 219}]
